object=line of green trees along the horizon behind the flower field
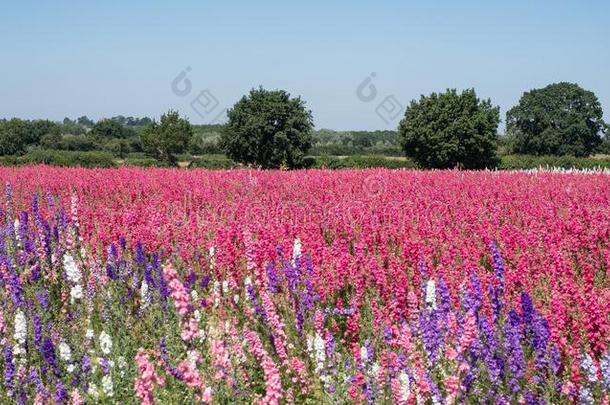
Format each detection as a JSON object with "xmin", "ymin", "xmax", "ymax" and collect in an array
[{"xmin": 0, "ymin": 83, "xmax": 610, "ymax": 169}]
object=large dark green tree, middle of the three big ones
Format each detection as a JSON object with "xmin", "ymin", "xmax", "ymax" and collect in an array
[{"xmin": 399, "ymin": 89, "xmax": 500, "ymax": 169}]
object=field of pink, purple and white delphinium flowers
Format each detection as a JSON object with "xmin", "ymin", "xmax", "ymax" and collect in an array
[{"xmin": 0, "ymin": 166, "xmax": 610, "ymax": 404}]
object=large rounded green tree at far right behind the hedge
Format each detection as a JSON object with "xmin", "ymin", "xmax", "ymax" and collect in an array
[{"xmin": 506, "ymin": 82, "xmax": 607, "ymax": 156}]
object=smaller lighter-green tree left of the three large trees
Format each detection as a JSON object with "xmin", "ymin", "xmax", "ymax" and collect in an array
[{"xmin": 140, "ymin": 110, "xmax": 193, "ymax": 165}]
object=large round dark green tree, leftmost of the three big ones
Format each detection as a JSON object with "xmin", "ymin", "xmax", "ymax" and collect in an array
[{"xmin": 220, "ymin": 88, "xmax": 313, "ymax": 169}]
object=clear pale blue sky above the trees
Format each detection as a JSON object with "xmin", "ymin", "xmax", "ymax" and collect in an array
[{"xmin": 0, "ymin": 0, "xmax": 610, "ymax": 129}]
